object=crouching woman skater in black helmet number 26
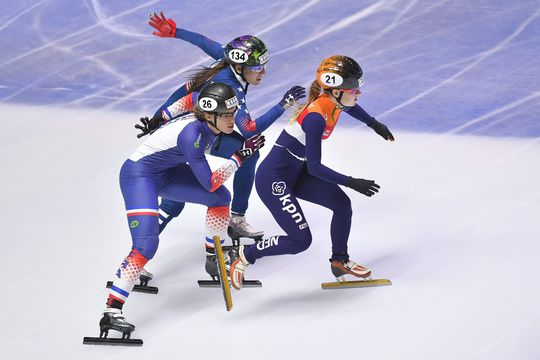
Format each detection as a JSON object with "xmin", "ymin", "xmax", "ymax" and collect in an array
[{"xmin": 100, "ymin": 83, "xmax": 264, "ymax": 334}]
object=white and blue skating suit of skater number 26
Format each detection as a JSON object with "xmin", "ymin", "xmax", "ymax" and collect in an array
[{"xmin": 107, "ymin": 115, "xmax": 239, "ymax": 307}]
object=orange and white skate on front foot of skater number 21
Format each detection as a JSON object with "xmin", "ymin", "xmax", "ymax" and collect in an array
[{"xmin": 321, "ymin": 260, "xmax": 392, "ymax": 289}]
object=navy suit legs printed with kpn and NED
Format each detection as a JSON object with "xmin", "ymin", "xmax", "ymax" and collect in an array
[{"xmin": 244, "ymin": 146, "xmax": 352, "ymax": 264}]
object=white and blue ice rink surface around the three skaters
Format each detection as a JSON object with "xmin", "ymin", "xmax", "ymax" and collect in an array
[{"xmin": 0, "ymin": 0, "xmax": 540, "ymax": 360}]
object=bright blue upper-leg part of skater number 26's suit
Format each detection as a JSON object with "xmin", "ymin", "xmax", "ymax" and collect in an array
[{"xmin": 120, "ymin": 160, "xmax": 231, "ymax": 260}]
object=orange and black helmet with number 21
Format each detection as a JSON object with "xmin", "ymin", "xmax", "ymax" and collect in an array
[{"xmin": 317, "ymin": 55, "xmax": 364, "ymax": 90}]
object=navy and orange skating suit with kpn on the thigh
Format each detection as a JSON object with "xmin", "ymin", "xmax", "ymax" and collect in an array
[{"xmin": 244, "ymin": 94, "xmax": 373, "ymax": 263}]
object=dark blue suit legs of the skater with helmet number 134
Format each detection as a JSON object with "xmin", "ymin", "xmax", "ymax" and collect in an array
[{"xmin": 159, "ymin": 136, "xmax": 259, "ymax": 233}]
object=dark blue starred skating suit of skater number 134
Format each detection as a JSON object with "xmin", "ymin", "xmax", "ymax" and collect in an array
[{"xmin": 156, "ymin": 29, "xmax": 284, "ymax": 217}]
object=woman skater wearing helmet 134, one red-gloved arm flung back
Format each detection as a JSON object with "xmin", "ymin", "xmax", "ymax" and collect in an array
[{"xmin": 136, "ymin": 13, "xmax": 305, "ymax": 242}]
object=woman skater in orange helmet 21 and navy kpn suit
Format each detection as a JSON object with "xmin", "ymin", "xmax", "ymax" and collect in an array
[{"xmin": 230, "ymin": 56, "xmax": 394, "ymax": 289}]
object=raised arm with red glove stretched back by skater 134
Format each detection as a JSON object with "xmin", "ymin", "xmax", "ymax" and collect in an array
[{"xmin": 148, "ymin": 12, "xmax": 223, "ymax": 60}]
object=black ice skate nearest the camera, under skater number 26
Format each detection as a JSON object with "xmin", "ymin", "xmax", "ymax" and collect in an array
[{"xmin": 83, "ymin": 308, "xmax": 143, "ymax": 346}]
